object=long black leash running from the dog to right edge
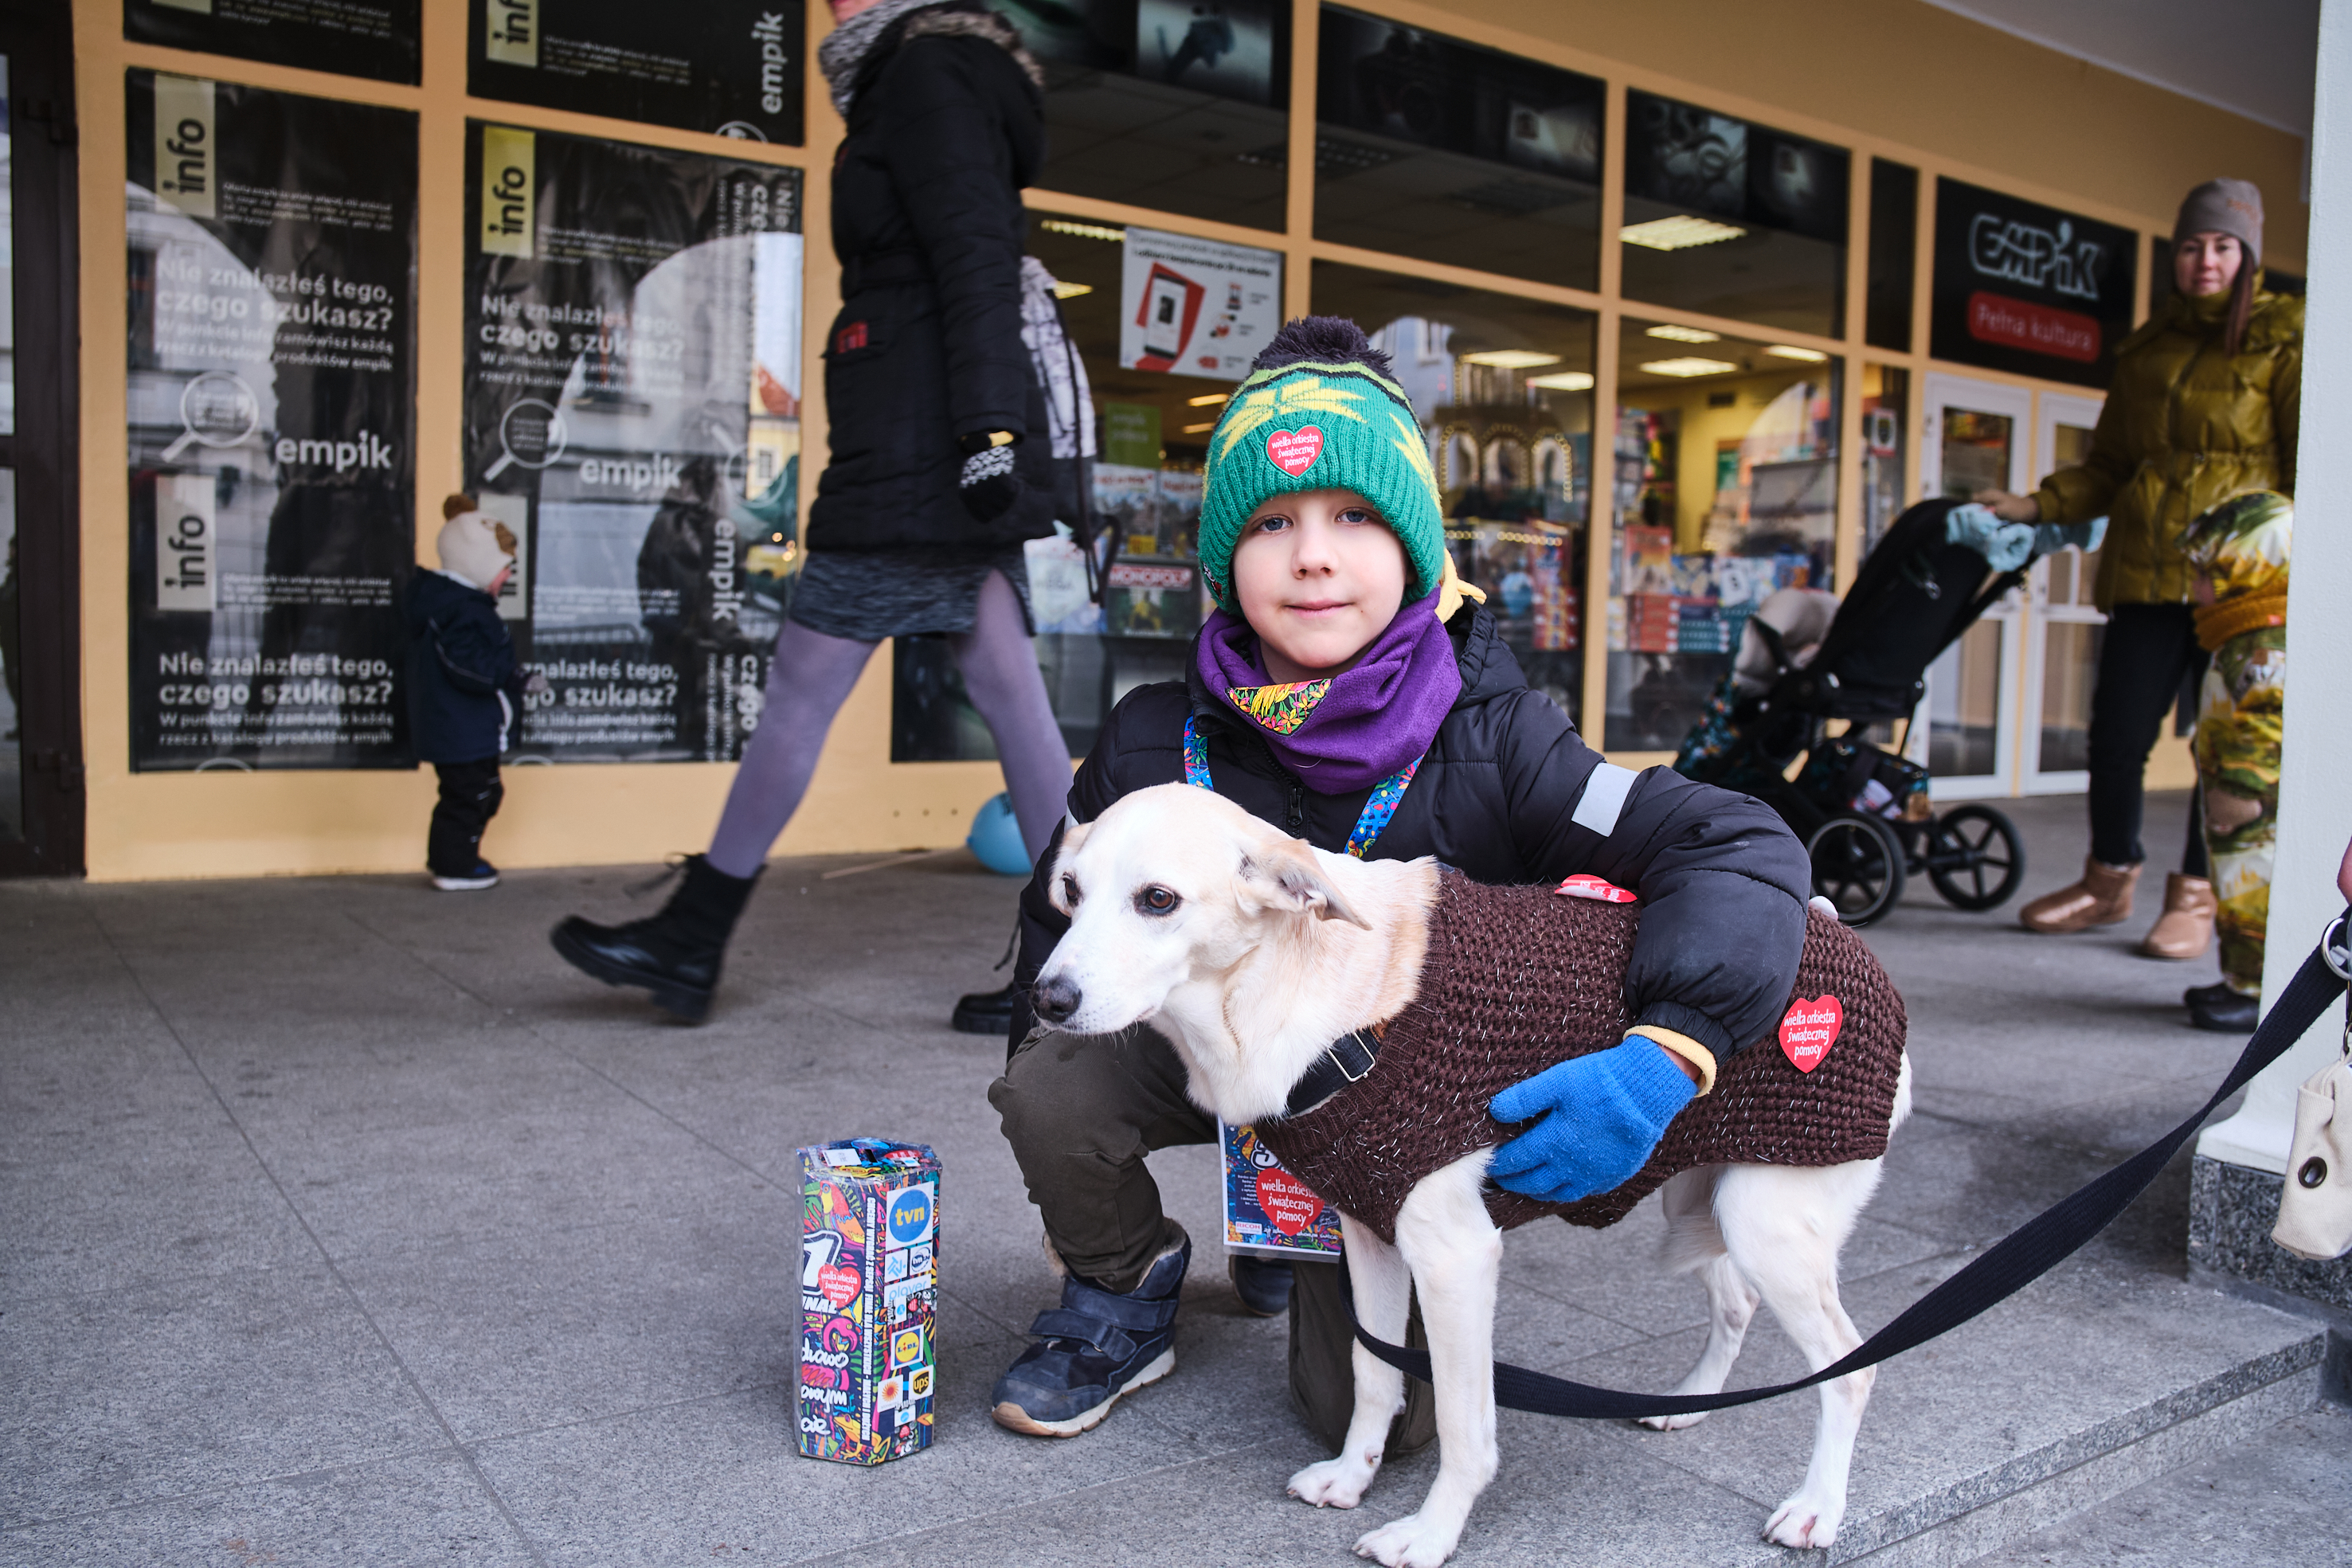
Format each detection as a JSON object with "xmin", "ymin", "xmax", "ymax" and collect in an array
[{"xmin": 1340, "ymin": 926, "xmax": 2345, "ymax": 1420}]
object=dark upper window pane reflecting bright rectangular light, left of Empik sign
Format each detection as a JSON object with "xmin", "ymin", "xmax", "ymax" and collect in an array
[{"xmin": 1618, "ymin": 92, "xmax": 1849, "ymax": 338}]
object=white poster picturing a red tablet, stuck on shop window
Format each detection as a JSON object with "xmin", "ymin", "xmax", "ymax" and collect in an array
[{"xmin": 1120, "ymin": 228, "xmax": 1282, "ymax": 381}]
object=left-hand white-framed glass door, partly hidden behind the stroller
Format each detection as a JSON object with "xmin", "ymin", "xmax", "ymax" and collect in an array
[{"xmin": 1908, "ymin": 373, "xmax": 2032, "ymax": 800}]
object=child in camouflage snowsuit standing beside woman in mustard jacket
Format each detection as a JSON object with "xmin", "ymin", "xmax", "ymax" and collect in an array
[{"xmin": 2182, "ymin": 489, "xmax": 2295, "ymax": 1032}]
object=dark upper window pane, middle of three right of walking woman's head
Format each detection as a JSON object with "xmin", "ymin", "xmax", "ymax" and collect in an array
[{"xmin": 1315, "ymin": 5, "xmax": 1606, "ymax": 289}]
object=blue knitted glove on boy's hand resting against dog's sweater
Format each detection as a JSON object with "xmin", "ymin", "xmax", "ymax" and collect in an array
[{"xmin": 1486, "ymin": 1034, "xmax": 1698, "ymax": 1203}]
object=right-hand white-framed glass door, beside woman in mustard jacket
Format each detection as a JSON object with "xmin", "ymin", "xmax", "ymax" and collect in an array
[{"xmin": 2025, "ymin": 393, "xmax": 2107, "ymax": 795}]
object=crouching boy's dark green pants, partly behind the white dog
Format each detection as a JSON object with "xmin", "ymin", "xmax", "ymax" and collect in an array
[{"xmin": 988, "ymin": 1030, "xmax": 1437, "ymax": 1453}]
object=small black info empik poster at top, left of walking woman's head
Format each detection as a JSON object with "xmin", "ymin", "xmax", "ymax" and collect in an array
[{"xmin": 466, "ymin": 0, "xmax": 809, "ymax": 146}]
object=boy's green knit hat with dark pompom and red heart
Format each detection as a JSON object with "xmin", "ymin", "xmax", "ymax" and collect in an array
[{"xmin": 1199, "ymin": 315, "xmax": 1446, "ymax": 616}]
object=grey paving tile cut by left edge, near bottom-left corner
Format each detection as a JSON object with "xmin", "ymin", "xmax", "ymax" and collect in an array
[{"xmin": 0, "ymin": 1267, "xmax": 447, "ymax": 1528}]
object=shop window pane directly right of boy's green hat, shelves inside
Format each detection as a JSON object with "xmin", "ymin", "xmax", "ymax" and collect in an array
[{"xmin": 1315, "ymin": 261, "xmax": 1592, "ymax": 717}]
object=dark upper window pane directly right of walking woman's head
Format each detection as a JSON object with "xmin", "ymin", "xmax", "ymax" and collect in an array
[{"xmin": 990, "ymin": 0, "xmax": 1291, "ymax": 228}]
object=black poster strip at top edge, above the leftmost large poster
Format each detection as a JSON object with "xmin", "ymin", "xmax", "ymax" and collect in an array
[{"xmin": 123, "ymin": 0, "xmax": 424, "ymax": 84}]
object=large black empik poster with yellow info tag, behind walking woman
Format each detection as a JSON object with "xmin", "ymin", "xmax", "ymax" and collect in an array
[{"xmin": 466, "ymin": 123, "xmax": 802, "ymax": 761}]
